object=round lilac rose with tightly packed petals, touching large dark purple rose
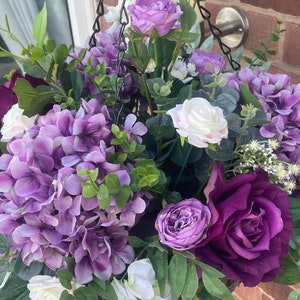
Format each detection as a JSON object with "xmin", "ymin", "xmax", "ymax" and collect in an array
[{"xmin": 155, "ymin": 198, "xmax": 211, "ymax": 251}]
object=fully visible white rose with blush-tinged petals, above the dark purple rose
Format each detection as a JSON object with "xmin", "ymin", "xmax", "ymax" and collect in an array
[{"xmin": 167, "ymin": 98, "xmax": 228, "ymax": 148}]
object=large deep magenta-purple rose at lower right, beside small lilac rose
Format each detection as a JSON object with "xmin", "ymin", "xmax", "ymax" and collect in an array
[{"xmin": 195, "ymin": 163, "xmax": 292, "ymax": 286}]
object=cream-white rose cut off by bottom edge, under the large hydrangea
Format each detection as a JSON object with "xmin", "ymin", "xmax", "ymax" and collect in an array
[{"xmin": 27, "ymin": 275, "xmax": 65, "ymax": 300}]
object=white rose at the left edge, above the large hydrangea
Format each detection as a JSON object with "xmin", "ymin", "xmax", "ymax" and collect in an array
[{"xmin": 1, "ymin": 104, "xmax": 36, "ymax": 142}]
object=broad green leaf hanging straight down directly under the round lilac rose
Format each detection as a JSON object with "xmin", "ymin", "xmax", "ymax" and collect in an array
[{"xmin": 168, "ymin": 255, "xmax": 187, "ymax": 300}]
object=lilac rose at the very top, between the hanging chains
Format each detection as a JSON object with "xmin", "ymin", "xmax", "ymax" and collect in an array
[{"xmin": 128, "ymin": 0, "xmax": 182, "ymax": 36}]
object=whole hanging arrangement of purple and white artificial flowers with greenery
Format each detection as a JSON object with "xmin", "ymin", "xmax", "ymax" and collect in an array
[{"xmin": 0, "ymin": 0, "xmax": 300, "ymax": 300}]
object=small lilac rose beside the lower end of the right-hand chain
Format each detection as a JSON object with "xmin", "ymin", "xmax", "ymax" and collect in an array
[{"xmin": 189, "ymin": 49, "xmax": 226, "ymax": 74}]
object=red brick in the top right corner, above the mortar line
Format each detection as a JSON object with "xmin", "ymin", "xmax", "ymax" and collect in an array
[{"xmin": 241, "ymin": 0, "xmax": 300, "ymax": 16}]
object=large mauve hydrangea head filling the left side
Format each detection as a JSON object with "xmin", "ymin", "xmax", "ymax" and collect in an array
[{"xmin": 0, "ymin": 99, "xmax": 147, "ymax": 284}]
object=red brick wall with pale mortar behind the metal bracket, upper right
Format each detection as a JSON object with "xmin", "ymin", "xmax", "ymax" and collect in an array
[{"xmin": 205, "ymin": 0, "xmax": 300, "ymax": 83}]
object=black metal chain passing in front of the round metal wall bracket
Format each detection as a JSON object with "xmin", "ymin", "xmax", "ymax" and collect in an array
[{"xmin": 197, "ymin": 1, "xmax": 241, "ymax": 71}]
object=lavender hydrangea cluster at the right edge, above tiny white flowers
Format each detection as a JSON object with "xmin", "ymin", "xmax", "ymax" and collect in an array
[{"xmin": 228, "ymin": 68, "xmax": 300, "ymax": 189}]
